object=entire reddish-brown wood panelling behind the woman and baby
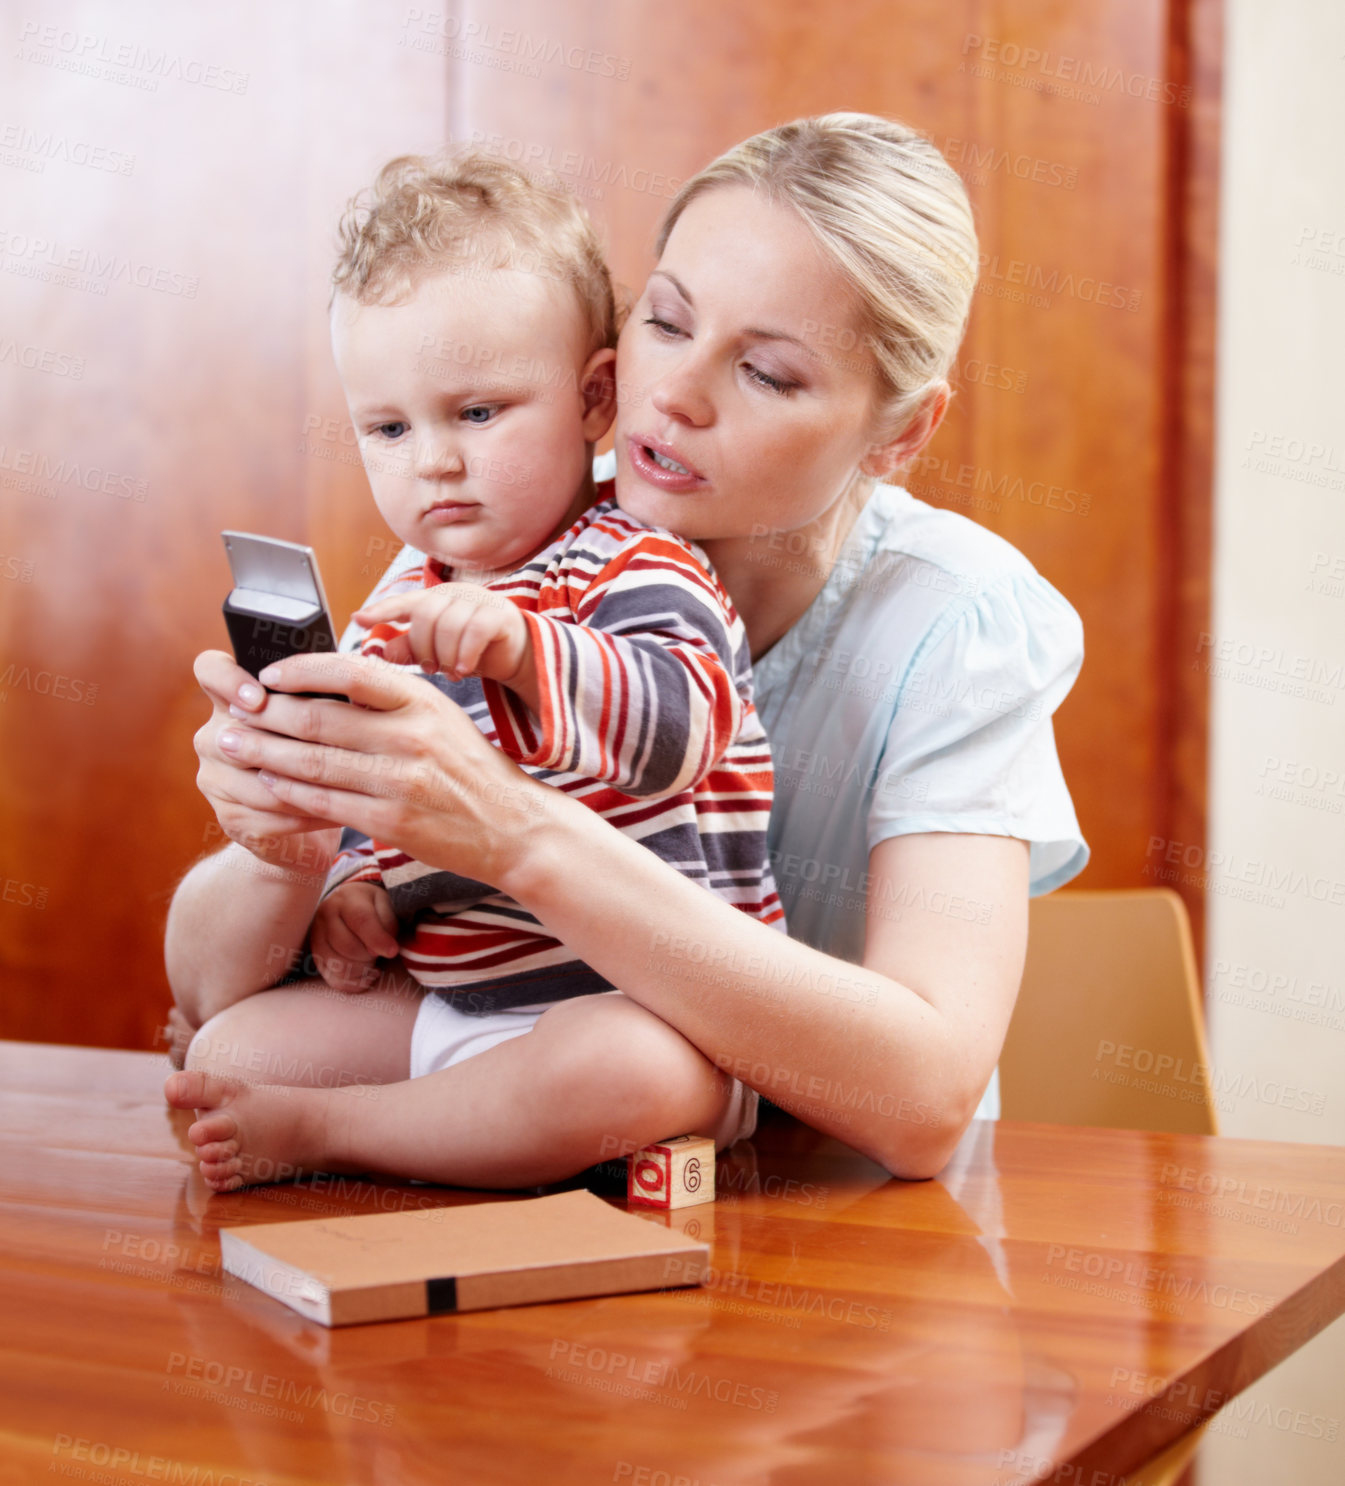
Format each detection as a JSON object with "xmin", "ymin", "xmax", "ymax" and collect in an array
[{"xmin": 0, "ymin": 0, "xmax": 1217, "ymax": 1046}]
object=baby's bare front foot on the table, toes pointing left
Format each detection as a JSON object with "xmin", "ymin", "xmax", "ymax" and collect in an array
[{"xmin": 163, "ymin": 1068, "xmax": 346, "ymax": 1192}]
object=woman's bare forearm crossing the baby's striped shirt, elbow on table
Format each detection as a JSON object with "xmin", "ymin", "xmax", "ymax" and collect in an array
[{"xmin": 499, "ymin": 802, "xmax": 984, "ymax": 1177}]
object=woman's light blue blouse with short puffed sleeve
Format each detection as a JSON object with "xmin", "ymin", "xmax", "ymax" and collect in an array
[{"xmin": 753, "ymin": 484, "xmax": 1088, "ymax": 1119}]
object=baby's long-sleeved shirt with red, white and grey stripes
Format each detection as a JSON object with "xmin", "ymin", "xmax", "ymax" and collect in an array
[{"xmin": 324, "ymin": 486, "xmax": 785, "ymax": 1013}]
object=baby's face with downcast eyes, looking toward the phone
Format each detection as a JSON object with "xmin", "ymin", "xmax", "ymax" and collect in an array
[{"xmin": 331, "ymin": 267, "xmax": 612, "ymax": 569}]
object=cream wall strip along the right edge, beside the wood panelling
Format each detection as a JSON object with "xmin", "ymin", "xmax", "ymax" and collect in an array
[{"xmin": 1195, "ymin": 0, "xmax": 1345, "ymax": 1486}]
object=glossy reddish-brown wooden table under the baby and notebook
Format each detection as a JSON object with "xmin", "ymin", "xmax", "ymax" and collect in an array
[{"xmin": 0, "ymin": 1043, "xmax": 1345, "ymax": 1486}]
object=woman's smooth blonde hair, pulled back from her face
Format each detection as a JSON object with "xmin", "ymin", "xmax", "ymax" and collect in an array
[{"xmin": 657, "ymin": 113, "xmax": 978, "ymax": 437}]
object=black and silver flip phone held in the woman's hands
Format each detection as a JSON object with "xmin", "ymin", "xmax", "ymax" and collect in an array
[{"xmin": 221, "ymin": 532, "xmax": 346, "ymax": 701}]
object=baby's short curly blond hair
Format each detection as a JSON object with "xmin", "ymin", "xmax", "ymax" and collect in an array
[{"xmin": 331, "ymin": 152, "xmax": 617, "ymax": 354}]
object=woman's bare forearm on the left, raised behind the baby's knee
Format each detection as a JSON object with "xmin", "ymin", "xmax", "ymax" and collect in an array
[{"xmin": 163, "ymin": 843, "xmax": 327, "ymax": 1025}]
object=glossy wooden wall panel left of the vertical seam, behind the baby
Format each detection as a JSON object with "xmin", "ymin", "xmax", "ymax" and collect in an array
[{"xmin": 0, "ymin": 0, "xmax": 444, "ymax": 1046}]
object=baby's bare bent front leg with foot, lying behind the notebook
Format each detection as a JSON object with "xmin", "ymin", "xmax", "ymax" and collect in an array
[{"xmin": 165, "ymin": 993, "xmax": 733, "ymax": 1192}]
